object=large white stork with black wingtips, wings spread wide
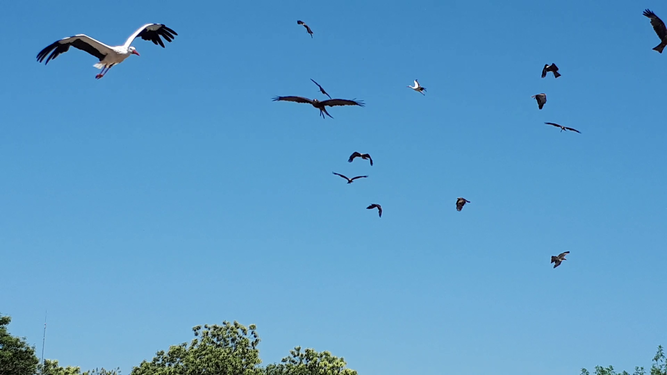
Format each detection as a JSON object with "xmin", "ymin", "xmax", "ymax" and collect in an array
[{"xmin": 37, "ymin": 23, "xmax": 178, "ymax": 79}]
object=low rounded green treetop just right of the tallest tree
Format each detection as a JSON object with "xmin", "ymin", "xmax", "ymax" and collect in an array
[{"xmin": 266, "ymin": 346, "xmax": 357, "ymax": 375}]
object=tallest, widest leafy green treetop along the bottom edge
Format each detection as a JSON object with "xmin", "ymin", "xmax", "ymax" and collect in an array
[{"xmin": 131, "ymin": 322, "xmax": 262, "ymax": 375}]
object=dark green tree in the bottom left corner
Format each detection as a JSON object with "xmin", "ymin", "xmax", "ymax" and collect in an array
[{"xmin": 0, "ymin": 316, "xmax": 39, "ymax": 375}]
